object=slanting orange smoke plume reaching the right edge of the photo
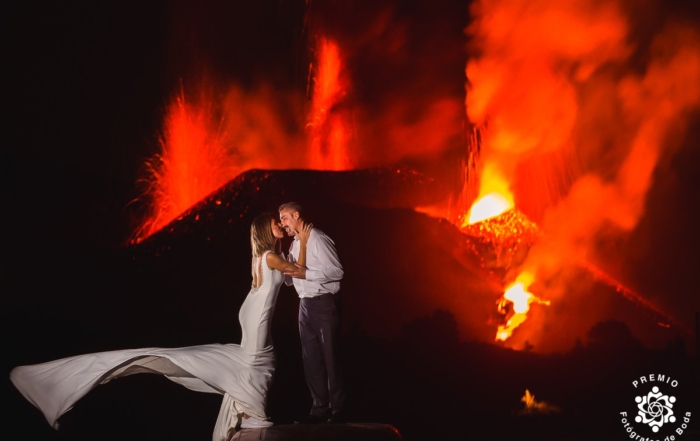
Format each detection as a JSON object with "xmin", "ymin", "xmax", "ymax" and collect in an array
[{"xmin": 544, "ymin": 22, "xmax": 700, "ymax": 257}]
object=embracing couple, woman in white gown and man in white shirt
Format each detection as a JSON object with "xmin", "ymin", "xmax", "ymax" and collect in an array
[{"xmin": 10, "ymin": 202, "xmax": 345, "ymax": 441}]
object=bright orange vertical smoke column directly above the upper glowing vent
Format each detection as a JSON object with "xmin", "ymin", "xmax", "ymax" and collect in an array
[{"xmin": 466, "ymin": 0, "xmax": 629, "ymax": 215}]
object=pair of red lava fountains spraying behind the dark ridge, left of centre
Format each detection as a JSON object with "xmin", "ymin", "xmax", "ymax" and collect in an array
[{"xmin": 131, "ymin": 38, "xmax": 352, "ymax": 243}]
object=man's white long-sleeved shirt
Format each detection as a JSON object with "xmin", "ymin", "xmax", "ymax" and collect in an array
[{"xmin": 284, "ymin": 228, "xmax": 344, "ymax": 298}]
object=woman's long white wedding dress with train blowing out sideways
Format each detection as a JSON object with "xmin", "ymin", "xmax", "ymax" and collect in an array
[{"xmin": 10, "ymin": 251, "xmax": 284, "ymax": 441}]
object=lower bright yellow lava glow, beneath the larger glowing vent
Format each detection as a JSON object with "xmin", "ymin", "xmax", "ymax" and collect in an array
[{"xmin": 496, "ymin": 272, "xmax": 549, "ymax": 341}]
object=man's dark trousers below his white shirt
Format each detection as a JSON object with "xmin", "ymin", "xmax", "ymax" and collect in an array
[{"xmin": 299, "ymin": 293, "xmax": 345, "ymax": 417}]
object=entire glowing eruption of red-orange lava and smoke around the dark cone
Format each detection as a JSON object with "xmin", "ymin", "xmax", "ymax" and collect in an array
[{"xmin": 121, "ymin": 0, "xmax": 700, "ymax": 350}]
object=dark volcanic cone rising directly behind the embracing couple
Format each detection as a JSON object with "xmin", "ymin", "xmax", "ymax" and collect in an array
[{"xmin": 128, "ymin": 165, "xmax": 496, "ymax": 344}]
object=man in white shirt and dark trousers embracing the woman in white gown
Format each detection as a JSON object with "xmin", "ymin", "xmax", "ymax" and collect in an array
[{"xmin": 279, "ymin": 202, "xmax": 345, "ymax": 424}]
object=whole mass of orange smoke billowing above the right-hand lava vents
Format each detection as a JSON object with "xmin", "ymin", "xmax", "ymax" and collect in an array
[{"xmin": 466, "ymin": 0, "xmax": 700, "ymax": 348}]
